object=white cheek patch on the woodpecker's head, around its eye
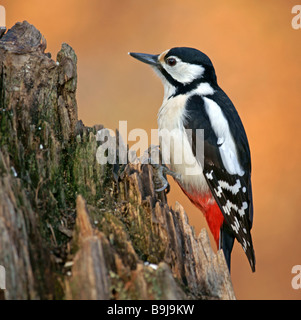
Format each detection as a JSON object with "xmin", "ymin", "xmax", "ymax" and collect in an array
[{"xmin": 162, "ymin": 58, "xmax": 205, "ymax": 84}]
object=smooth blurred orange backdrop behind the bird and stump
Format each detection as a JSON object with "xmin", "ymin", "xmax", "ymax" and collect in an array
[{"xmin": 0, "ymin": 0, "xmax": 301, "ymax": 299}]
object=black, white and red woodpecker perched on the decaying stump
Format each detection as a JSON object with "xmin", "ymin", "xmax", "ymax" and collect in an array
[{"xmin": 129, "ymin": 47, "xmax": 255, "ymax": 272}]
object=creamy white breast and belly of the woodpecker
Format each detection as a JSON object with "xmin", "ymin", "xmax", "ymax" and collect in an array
[{"xmin": 158, "ymin": 95, "xmax": 209, "ymax": 193}]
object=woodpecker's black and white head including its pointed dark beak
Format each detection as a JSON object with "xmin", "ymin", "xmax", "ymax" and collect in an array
[{"xmin": 129, "ymin": 47, "xmax": 217, "ymax": 94}]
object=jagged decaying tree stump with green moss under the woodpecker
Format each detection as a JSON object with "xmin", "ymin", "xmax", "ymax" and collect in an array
[{"xmin": 0, "ymin": 22, "xmax": 235, "ymax": 299}]
